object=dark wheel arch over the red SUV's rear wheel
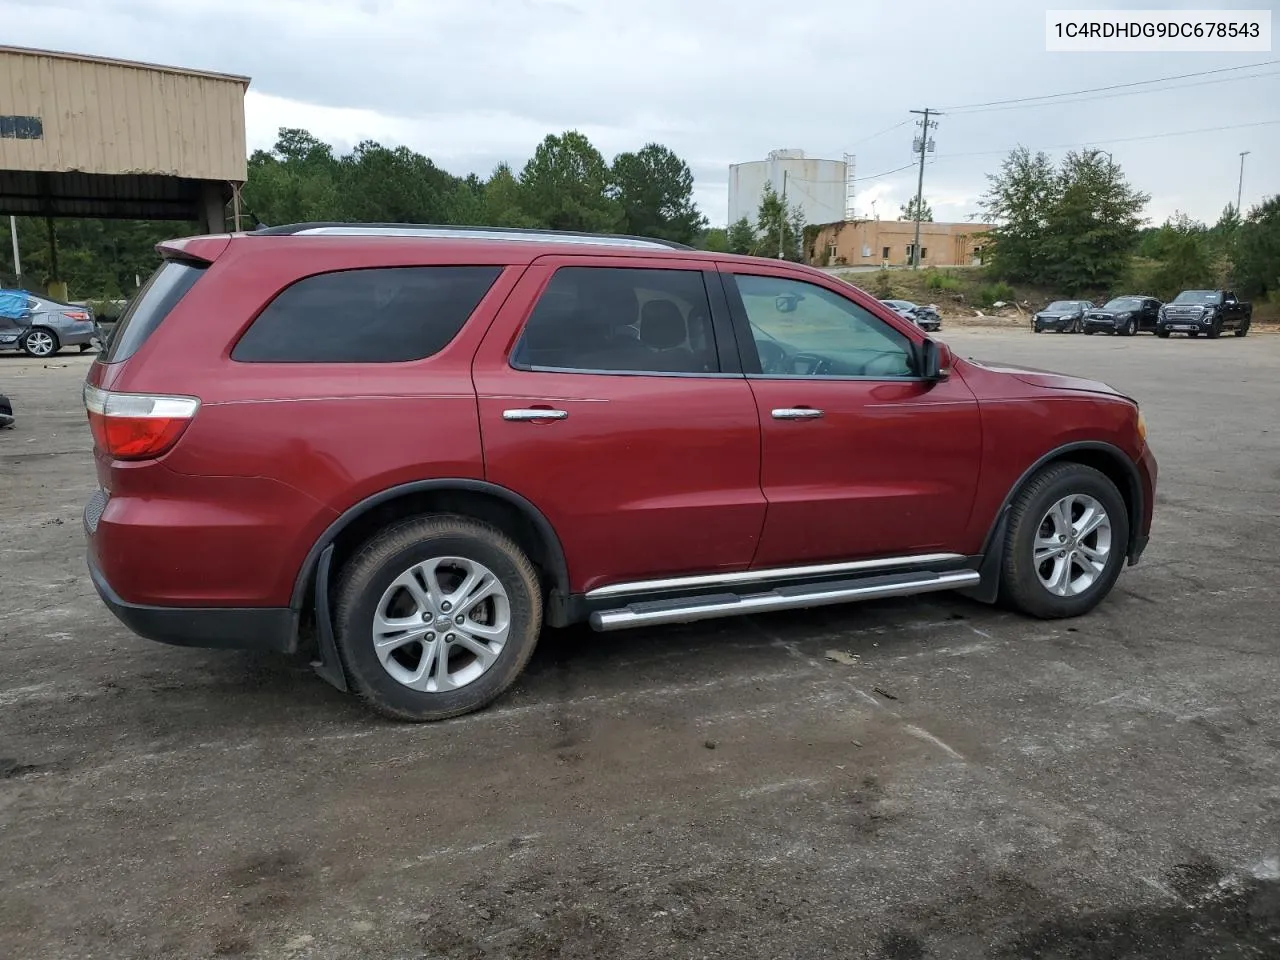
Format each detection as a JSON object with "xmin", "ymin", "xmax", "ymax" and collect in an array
[{"xmin": 289, "ymin": 477, "xmax": 570, "ymax": 626}]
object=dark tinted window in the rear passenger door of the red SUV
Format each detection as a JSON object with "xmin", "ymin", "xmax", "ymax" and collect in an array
[{"xmin": 511, "ymin": 266, "xmax": 719, "ymax": 374}]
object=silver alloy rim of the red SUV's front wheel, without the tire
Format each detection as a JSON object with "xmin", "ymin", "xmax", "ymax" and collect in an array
[{"xmin": 1033, "ymin": 494, "xmax": 1111, "ymax": 596}]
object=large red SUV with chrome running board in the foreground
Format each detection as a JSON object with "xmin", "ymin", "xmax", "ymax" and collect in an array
[{"xmin": 84, "ymin": 224, "xmax": 1156, "ymax": 721}]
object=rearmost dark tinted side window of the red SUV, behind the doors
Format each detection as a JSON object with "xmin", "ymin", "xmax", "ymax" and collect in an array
[{"xmin": 232, "ymin": 266, "xmax": 502, "ymax": 364}]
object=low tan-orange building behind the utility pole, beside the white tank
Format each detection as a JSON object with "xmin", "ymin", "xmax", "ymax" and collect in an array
[{"xmin": 805, "ymin": 220, "xmax": 991, "ymax": 266}]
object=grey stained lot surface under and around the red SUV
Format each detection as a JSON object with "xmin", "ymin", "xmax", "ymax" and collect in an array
[{"xmin": 0, "ymin": 328, "xmax": 1280, "ymax": 960}]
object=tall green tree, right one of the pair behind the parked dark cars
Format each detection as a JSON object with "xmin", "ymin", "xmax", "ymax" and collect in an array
[{"xmin": 1039, "ymin": 150, "xmax": 1151, "ymax": 293}]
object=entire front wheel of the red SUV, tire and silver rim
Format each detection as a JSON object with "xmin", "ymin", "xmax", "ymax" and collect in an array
[{"xmin": 1001, "ymin": 463, "xmax": 1129, "ymax": 620}]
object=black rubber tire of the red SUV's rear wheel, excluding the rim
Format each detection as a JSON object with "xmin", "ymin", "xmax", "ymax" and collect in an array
[{"xmin": 334, "ymin": 515, "xmax": 543, "ymax": 722}]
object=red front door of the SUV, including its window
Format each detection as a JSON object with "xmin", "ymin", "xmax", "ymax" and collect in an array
[{"xmin": 721, "ymin": 265, "xmax": 982, "ymax": 567}]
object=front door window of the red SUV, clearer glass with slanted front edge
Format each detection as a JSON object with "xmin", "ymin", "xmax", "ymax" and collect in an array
[{"xmin": 733, "ymin": 274, "xmax": 915, "ymax": 380}]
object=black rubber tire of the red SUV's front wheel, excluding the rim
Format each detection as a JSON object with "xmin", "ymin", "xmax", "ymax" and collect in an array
[{"xmin": 1000, "ymin": 463, "xmax": 1129, "ymax": 620}]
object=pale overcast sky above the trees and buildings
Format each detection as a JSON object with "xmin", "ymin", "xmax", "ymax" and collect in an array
[{"xmin": 0, "ymin": 0, "xmax": 1280, "ymax": 224}]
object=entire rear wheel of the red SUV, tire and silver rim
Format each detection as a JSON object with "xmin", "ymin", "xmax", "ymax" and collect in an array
[{"xmin": 334, "ymin": 516, "xmax": 543, "ymax": 722}]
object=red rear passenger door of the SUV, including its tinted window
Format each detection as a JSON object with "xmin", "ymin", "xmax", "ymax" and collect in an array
[{"xmin": 474, "ymin": 256, "xmax": 764, "ymax": 593}]
